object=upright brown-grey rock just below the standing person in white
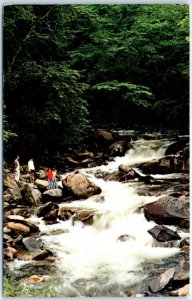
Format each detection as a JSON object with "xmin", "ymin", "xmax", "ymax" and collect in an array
[{"xmin": 21, "ymin": 184, "xmax": 42, "ymax": 206}]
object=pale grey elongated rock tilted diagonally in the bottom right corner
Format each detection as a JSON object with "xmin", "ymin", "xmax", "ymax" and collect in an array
[{"xmin": 149, "ymin": 268, "xmax": 175, "ymax": 293}]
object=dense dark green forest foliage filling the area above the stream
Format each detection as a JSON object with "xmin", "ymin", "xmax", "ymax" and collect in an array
[{"xmin": 3, "ymin": 4, "xmax": 189, "ymax": 157}]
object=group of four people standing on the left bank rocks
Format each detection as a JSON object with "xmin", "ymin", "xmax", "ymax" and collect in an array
[{"xmin": 14, "ymin": 155, "xmax": 57, "ymax": 189}]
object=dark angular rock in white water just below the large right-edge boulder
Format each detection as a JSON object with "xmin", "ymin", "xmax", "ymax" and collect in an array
[{"xmin": 148, "ymin": 225, "xmax": 181, "ymax": 242}]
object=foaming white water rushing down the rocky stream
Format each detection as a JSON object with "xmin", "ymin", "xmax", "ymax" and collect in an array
[{"xmin": 4, "ymin": 135, "xmax": 189, "ymax": 297}]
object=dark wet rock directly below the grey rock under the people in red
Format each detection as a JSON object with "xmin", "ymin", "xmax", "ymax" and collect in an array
[{"xmin": 37, "ymin": 202, "xmax": 59, "ymax": 221}]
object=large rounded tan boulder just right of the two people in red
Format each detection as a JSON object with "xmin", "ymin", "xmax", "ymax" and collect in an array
[{"xmin": 62, "ymin": 172, "xmax": 101, "ymax": 199}]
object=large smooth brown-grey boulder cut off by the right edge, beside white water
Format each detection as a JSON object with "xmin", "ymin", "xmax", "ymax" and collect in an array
[{"xmin": 144, "ymin": 196, "xmax": 189, "ymax": 228}]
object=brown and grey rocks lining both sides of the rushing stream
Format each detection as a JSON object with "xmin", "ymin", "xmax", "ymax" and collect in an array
[{"xmin": 3, "ymin": 130, "xmax": 189, "ymax": 296}]
